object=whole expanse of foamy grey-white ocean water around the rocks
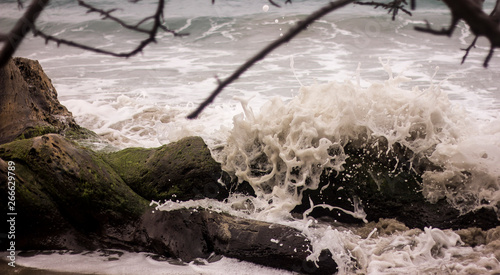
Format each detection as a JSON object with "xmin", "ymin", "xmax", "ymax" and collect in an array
[{"xmin": 0, "ymin": 0, "xmax": 500, "ymax": 274}]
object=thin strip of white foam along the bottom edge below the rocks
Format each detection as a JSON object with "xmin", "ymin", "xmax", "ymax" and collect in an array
[{"xmin": 6, "ymin": 250, "xmax": 293, "ymax": 275}]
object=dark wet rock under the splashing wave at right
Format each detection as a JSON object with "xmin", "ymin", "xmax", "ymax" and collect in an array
[{"xmin": 294, "ymin": 138, "xmax": 500, "ymax": 229}]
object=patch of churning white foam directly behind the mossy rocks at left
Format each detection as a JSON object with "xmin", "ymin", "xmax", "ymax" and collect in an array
[{"xmin": 64, "ymin": 94, "xmax": 237, "ymax": 148}]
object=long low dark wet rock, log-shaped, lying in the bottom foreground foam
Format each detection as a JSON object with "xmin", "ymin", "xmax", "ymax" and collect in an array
[{"xmin": 143, "ymin": 209, "xmax": 337, "ymax": 274}]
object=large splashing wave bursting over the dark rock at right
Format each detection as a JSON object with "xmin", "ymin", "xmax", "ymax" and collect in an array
[{"xmin": 213, "ymin": 66, "xmax": 500, "ymax": 220}]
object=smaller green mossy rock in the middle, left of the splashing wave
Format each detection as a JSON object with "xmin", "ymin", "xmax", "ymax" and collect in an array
[{"xmin": 103, "ymin": 137, "xmax": 228, "ymax": 201}]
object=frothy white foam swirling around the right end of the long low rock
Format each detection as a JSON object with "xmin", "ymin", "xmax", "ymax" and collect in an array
[{"xmin": 155, "ymin": 196, "xmax": 500, "ymax": 274}]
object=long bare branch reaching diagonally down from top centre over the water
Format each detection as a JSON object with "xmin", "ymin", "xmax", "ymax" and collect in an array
[{"xmin": 187, "ymin": 0, "xmax": 354, "ymax": 119}]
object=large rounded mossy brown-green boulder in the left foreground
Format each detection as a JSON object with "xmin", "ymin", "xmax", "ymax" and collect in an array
[{"xmin": 0, "ymin": 134, "xmax": 148, "ymax": 249}]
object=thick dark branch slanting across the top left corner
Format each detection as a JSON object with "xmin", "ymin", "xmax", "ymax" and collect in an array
[{"xmin": 0, "ymin": 0, "xmax": 49, "ymax": 68}]
